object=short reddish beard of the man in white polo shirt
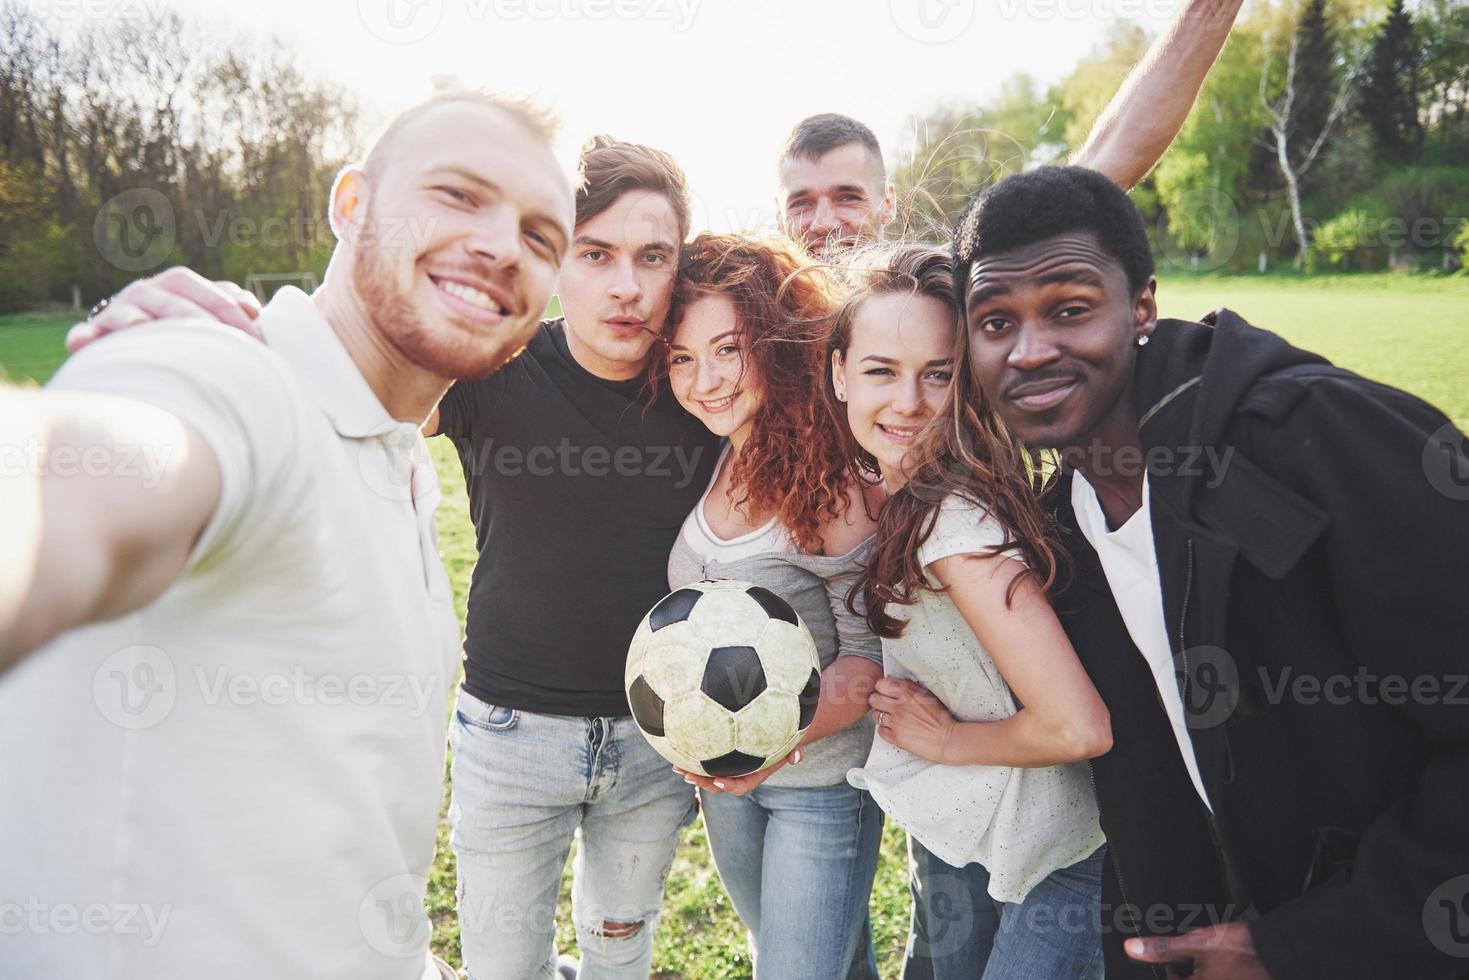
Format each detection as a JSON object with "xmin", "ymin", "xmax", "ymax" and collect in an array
[{"xmin": 353, "ymin": 218, "xmax": 536, "ymax": 381}]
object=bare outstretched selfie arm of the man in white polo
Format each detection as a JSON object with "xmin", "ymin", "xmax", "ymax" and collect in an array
[{"xmin": 0, "ymin": 386, "xmax": 220, "ymax": 671}]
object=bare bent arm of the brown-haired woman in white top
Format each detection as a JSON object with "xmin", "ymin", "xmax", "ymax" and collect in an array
[{"xmin": 871, "ymin": 554, "xmax": 1112, "ymax": 767}]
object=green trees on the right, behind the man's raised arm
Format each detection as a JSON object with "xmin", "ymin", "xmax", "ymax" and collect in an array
[{"xmin": 896, "ymin": 0, "xmax": 1469, "ymax": 272}]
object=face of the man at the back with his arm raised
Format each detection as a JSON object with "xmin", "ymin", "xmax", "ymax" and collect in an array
[{"xmin": 780, "ymin": 143, "xmax": 896, "ymax": 256}]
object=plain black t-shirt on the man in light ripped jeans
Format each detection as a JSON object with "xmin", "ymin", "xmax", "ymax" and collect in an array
[{"xmin": 439, "ymin": 320, "xmax": 718, "ymax": 717}]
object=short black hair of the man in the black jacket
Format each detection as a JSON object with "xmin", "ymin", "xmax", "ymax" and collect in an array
[{"xmin": 953, "ymin": 166, "xmax": 1153, "ymax": 301}]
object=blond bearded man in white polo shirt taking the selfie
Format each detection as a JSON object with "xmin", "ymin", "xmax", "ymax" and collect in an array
[{"xmin": 0, "ymin": 88, "xmax": 571, "ymax": 980}]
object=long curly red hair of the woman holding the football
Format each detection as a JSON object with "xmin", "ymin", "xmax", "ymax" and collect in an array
[{"xmin": 649, "ymin": 232, "xmax": 851, "ymax": 554}]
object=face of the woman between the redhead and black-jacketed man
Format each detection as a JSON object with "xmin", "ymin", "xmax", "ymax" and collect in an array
[{"xmin": 831, "ymin": 292, "xmax": 955, "ymax": 491}]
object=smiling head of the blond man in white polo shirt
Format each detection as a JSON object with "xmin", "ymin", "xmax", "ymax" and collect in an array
[{"xmin": 343, "ymin": 101, "xmax": 571, "ymax": 379}]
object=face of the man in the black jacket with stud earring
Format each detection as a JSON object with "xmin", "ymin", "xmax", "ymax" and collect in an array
[{"xmin": 965, "ymin": 232, "xmax": 1158, "ymax": 448}]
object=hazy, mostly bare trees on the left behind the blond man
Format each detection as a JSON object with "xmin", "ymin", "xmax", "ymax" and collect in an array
[{"xmin": 0, "ymin": 1, "xmax": 361, "ymax": 311}]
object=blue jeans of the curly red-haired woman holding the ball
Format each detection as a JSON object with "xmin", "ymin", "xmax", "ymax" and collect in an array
[{"xmin": 699, "ymin": 782, "xmax": 883, "ymax": 980}]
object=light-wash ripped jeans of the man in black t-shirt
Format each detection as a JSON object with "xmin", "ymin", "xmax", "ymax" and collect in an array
[{"xmin": 450, "ymin": 689, "xmax": 695, "ymax": 980}]
